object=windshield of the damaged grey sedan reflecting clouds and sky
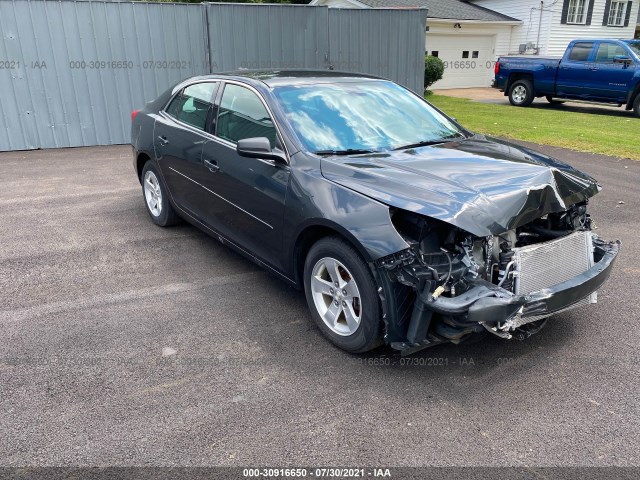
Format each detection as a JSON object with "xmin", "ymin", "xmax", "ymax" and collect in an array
[{"xmin": 274, "ymin": 80, "xmax": 463, "ymax": 153}]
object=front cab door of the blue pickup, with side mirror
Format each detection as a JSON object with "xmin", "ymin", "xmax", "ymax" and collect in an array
[{"xmin": 590, "ymin": 42, "xmax": 638, "ymax": 103}]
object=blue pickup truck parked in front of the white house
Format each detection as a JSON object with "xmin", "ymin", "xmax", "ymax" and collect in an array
[{"xmin": 493, "ymin": 39, "xmax": 640, "ymax": 116}]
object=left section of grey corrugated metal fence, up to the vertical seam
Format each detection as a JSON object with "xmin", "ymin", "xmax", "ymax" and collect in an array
[{"xmin": 0, "ymin": 0, "xmax": 208, "ymax": 150}]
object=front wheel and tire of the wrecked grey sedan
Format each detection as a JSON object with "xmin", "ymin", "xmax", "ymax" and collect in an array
[{"xmin": 304, "ymin": 237, "xmax": 383, "ymax": 353}]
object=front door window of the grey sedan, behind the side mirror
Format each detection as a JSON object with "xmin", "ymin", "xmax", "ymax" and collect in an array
[{"xmin": 216, "ymin": 84, "xmax": 276, "ymax": 148}]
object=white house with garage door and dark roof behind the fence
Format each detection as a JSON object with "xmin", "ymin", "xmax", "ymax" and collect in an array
[{"xmin": 311, "ymin": 0, "xmax": 640, "ymax": 88}]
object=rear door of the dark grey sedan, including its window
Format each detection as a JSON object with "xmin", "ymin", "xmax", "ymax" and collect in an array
[{"xmin": 154, "ymin": 82, "xmax": 219, "ymax": 219}]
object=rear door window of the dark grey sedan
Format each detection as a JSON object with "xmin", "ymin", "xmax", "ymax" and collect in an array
[{"xmin": 166, "ymin": 82, "xmax": 218, "ymax": 130}]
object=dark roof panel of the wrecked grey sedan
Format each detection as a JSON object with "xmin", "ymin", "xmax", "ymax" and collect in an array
[{"xmin": 185, "ymin": 69, "xmax": 381, "ymax": 87}]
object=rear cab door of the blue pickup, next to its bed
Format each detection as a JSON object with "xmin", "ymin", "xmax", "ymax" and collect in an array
[{"xmin": 556, "ymin": 42, "xmax": 595, "ymax": 99}]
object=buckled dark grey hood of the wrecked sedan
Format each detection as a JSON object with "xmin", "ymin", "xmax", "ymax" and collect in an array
[{"xmin": 321, "ymin": 136, "xmax": 600, "ymax": 236}]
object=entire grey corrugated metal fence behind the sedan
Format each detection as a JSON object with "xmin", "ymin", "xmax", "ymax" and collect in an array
[{"xmin": 0, "ymin": 0, "xmax": 426, "ymax": 150}]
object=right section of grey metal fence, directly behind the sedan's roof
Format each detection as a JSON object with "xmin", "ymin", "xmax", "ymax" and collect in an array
[{"xmin": 207, "ymin": 4, "xmax": 427, "ymax": 92}]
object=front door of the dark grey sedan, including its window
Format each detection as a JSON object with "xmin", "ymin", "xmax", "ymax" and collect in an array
[{"xmin": 202, "ymin": 83, "xmax": 289, "ymax": 267}]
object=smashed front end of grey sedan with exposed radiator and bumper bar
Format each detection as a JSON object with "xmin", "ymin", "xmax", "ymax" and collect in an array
[{"xmin": 376, "ymin": 202, "xmax": 620, "ymax": 353}]
